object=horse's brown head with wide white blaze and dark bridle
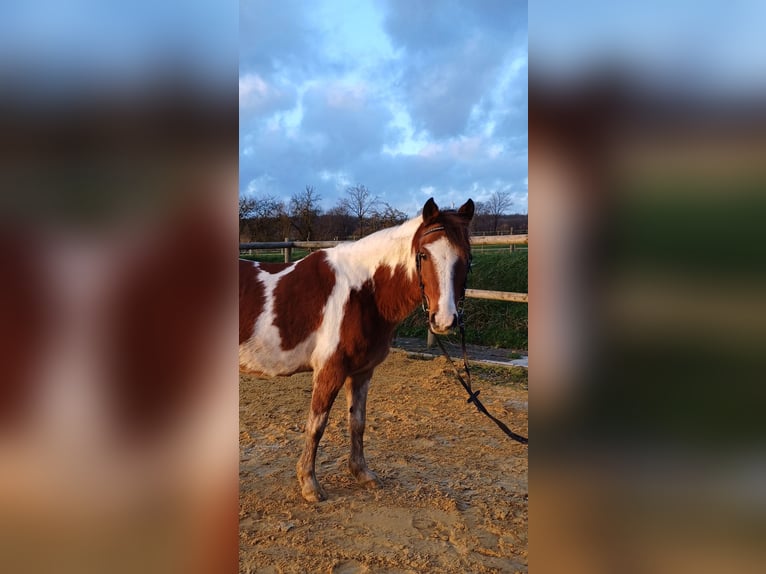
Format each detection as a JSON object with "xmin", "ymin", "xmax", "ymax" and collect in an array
[{"xmin": 412, "ymin": 198, "xmax": 474, "ymax": 334}]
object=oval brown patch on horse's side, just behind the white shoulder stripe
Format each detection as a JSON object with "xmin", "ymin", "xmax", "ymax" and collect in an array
[{"xmin": 274, "ymin": 251, "xmax": 335, "ymax": 351}]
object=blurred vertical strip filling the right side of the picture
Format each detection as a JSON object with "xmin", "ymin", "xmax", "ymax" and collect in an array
[{"xmin": 529, "ymin": 1, "xmax": 766, "ymax": 573}]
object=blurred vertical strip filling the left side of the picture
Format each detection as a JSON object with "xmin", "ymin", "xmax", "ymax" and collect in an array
[{"xmin": 0, "ymin": 0, "xmax": 238, "ymax": 572}]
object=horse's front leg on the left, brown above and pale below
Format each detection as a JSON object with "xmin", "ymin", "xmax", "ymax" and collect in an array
[{"xmin": 296, "ymin": 365, "xmax": 346, "ymax": 502}]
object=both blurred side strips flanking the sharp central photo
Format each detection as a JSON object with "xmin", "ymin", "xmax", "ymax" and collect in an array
[{"xmin": 6, "ymin": 0, "xmax": 766, "ymax": 573}]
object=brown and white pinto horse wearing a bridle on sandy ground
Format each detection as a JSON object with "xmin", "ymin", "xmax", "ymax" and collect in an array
[{"xmin": 239, "ymin": 198, "xmax": 474, "ymax": 502}]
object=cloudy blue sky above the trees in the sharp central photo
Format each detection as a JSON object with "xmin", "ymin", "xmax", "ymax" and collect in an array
[{"xmin": 239, "ymin": 0, "xmax": 527, "ymax": 215}]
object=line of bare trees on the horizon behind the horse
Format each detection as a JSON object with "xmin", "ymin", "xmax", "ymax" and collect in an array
[{"xmin": 239, "ymin": 184, "xmax": 527, "ymax": 241}]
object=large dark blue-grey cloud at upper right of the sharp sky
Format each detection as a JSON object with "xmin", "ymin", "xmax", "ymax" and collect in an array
[{"xmin": 385, "ymin": 2, "xmax": 526, "ymax": 138}]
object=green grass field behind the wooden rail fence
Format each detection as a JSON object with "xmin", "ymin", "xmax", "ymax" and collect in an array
[{"xmin": 241, "ymin": 247, "xmax": 528, "ymax": 351}]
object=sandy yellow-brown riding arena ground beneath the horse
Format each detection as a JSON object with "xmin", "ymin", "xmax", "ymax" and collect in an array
[{"xmin": 240, "ymin": 351, "xmax": 527, "ymax": 574}]
